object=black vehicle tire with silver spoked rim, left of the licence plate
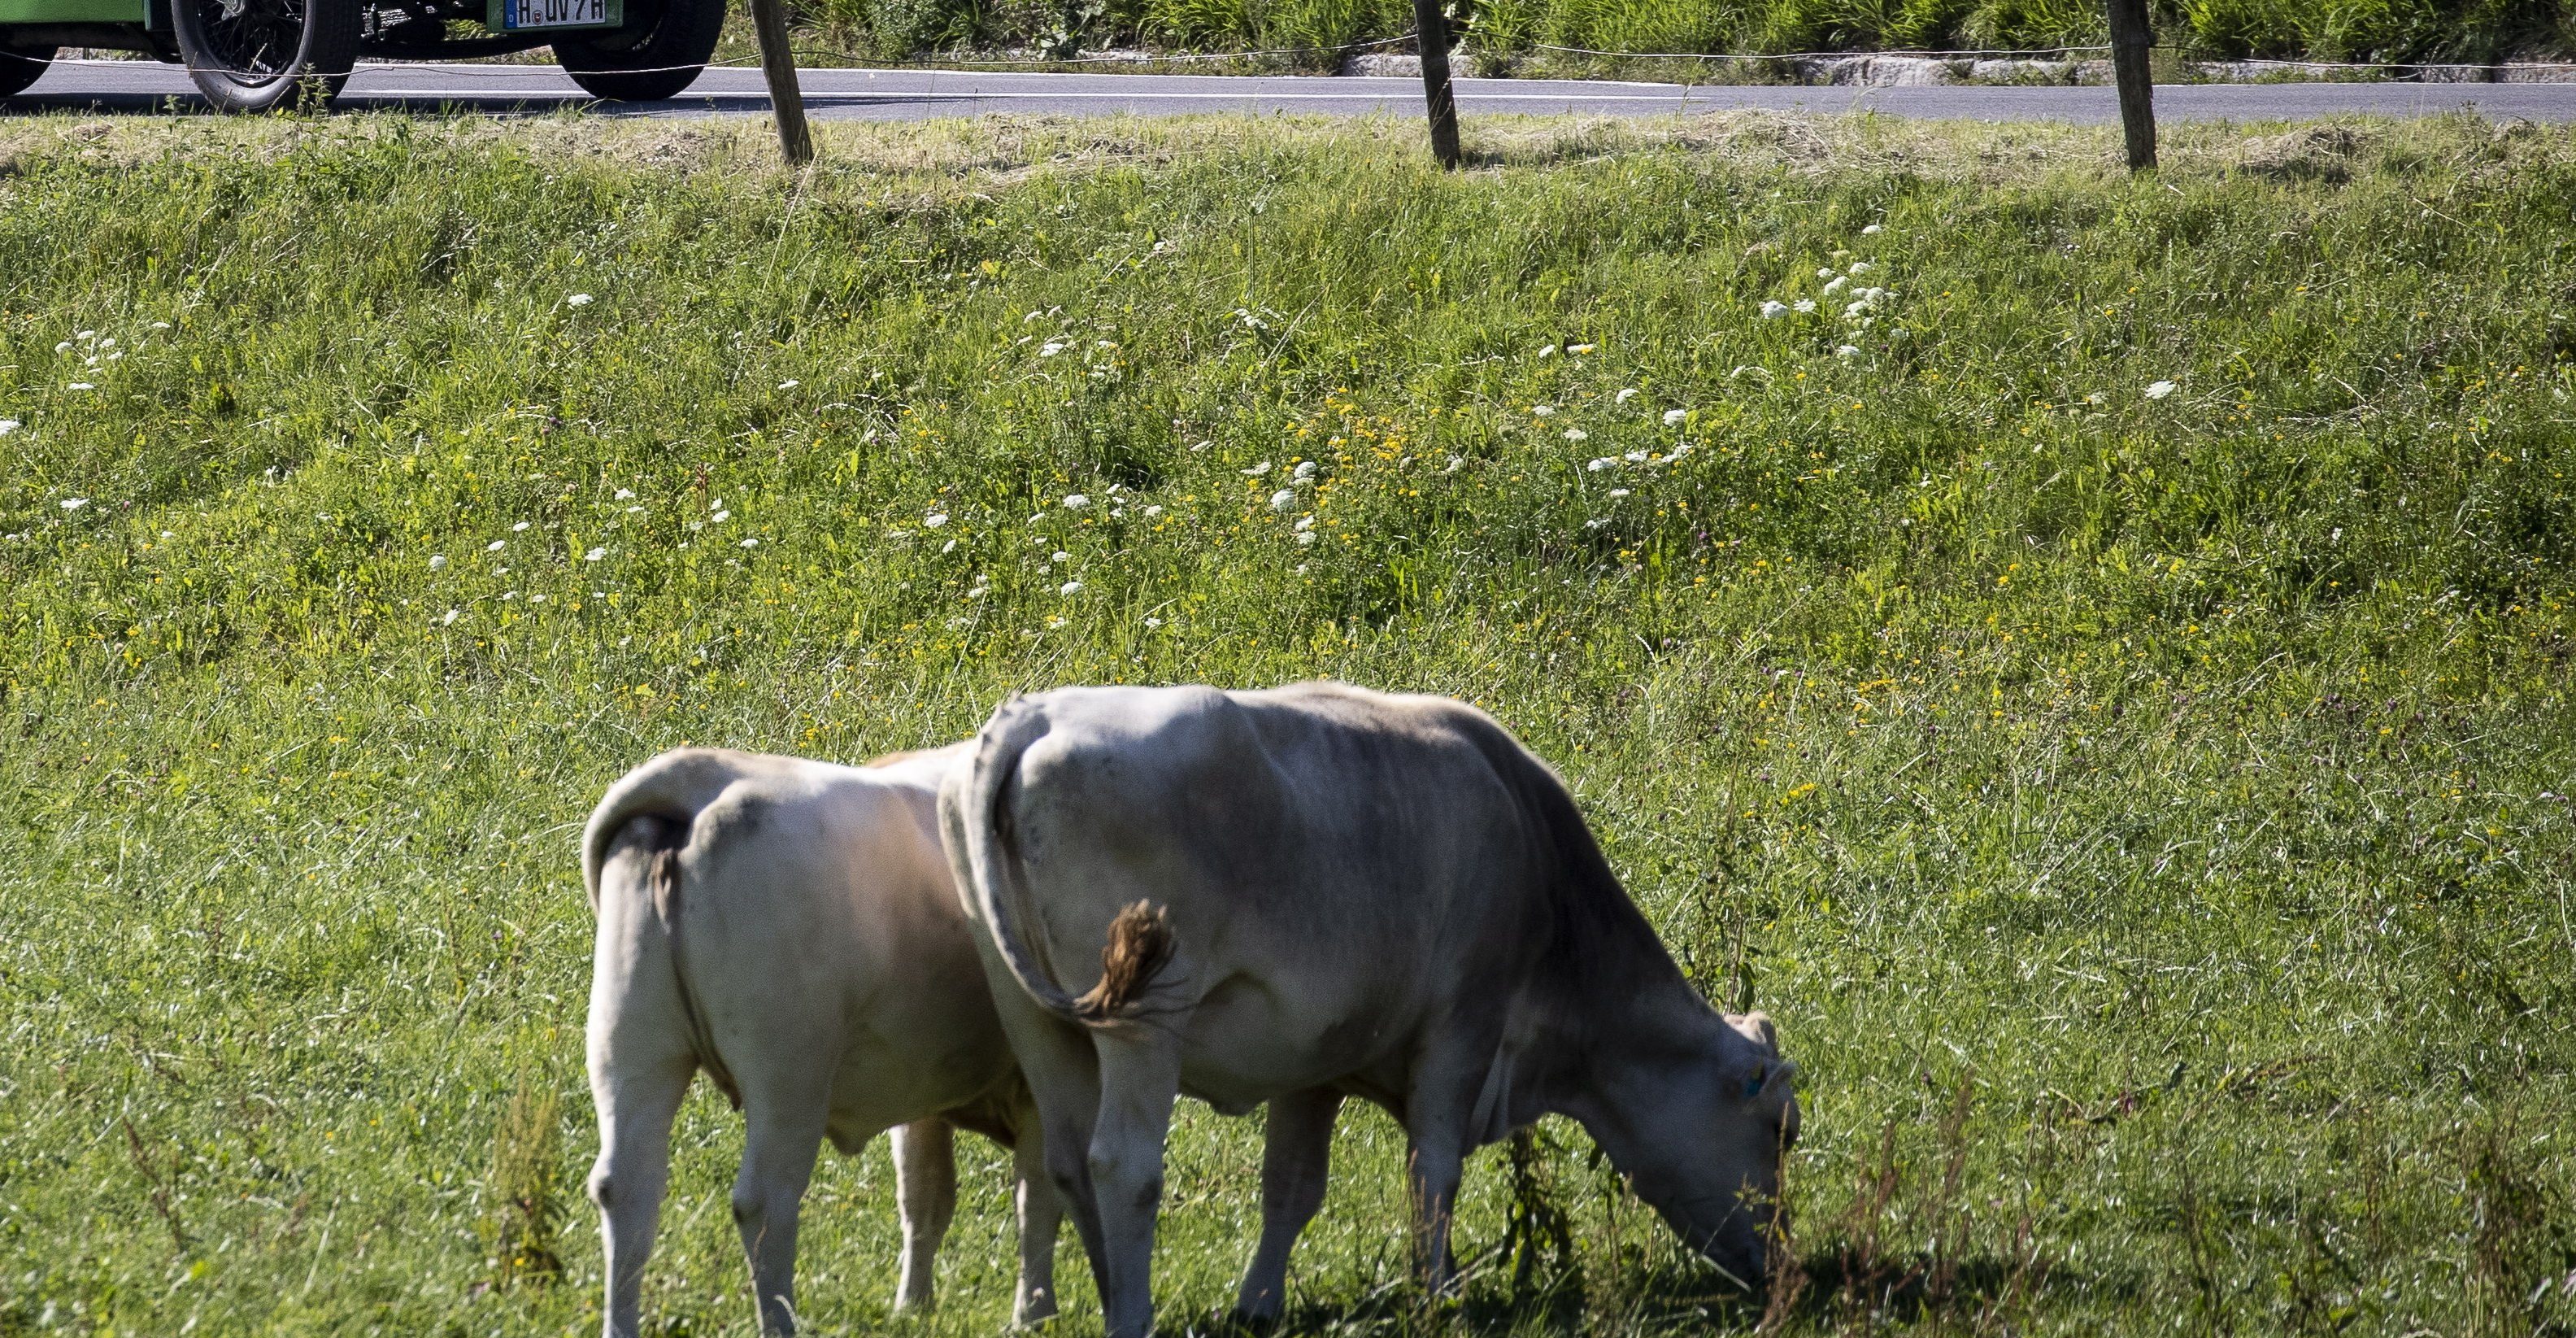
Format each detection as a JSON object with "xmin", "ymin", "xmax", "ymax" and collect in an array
[{"xmin": 170, "ymin": 0, "xmax": 358, "ymax": 111}]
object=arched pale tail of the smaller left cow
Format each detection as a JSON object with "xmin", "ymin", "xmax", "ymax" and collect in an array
[{"xmin": 582, "ymin": 747, "xmax": 742, "ymax": 1109}]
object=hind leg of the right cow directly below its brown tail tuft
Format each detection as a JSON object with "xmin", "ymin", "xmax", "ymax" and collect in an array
[{"xmin": 1090, "ymin": 1023, "xmax": 1180, "ymax": 1338}]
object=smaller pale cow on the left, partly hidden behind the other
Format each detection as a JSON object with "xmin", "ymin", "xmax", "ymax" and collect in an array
[{"xmin": 582, "ymin": 745, "xmax": 1061, "ymax": 1338}]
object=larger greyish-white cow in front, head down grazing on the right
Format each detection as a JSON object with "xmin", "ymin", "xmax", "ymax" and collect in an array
[{"xmin": 940, "ymin": 683, "xmax": 1798, "ymax": 1338}]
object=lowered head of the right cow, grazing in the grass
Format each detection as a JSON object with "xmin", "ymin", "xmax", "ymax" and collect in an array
[{"xmin": 1584, "ymin": 1010, "xmax": 1798, "ymax": 1287}]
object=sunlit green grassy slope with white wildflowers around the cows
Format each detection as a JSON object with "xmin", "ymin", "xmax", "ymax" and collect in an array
[{"xmin": 0, "ymin": 116, "xmax": 2576, "ymax": 1338}]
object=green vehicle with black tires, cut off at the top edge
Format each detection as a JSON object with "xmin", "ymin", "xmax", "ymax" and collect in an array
[{"xmin": 0, "ymin": 0, "xmax": 724, "ymax": 111}]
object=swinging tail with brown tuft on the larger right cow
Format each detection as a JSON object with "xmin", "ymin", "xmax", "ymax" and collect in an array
[{"xmin": 946, "ymin": 696, "xmax": 1180, "ymax": 1023}]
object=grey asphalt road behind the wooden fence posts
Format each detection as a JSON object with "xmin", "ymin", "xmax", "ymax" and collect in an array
[{"xmin": 15, "ymin": 62, "xmax": 2576, "ymax": 124}]
